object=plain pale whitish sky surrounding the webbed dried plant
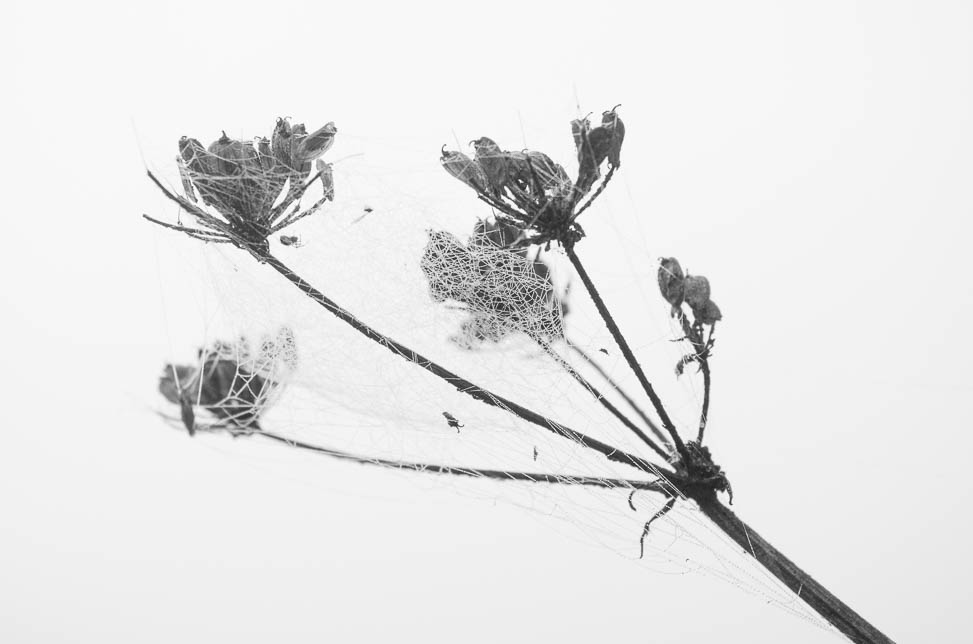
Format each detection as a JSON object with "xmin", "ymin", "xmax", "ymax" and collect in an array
[{"xmin": 0, "ymin": 1, "xmax": 973, "ymax": 643}]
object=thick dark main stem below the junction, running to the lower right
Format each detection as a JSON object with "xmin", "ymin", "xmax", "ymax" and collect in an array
[{"xmin": 694, "ymin": 493, "xmax": 892, "ymax": 644}]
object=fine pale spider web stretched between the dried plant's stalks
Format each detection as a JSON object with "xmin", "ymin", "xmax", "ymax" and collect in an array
[{"xmin": 152, "ymin": 137, "xmax": 824, "ymax": 626}]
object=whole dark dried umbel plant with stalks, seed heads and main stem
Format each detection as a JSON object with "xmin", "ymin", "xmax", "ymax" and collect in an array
[{"xmin": 149, "ymin": 113, "xmax": 890, "ymax": 642}]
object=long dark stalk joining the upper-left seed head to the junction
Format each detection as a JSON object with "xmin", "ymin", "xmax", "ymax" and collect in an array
[{"xmin": 254, "ymin": 251, "xmax": 659, "ymax": 476}]
